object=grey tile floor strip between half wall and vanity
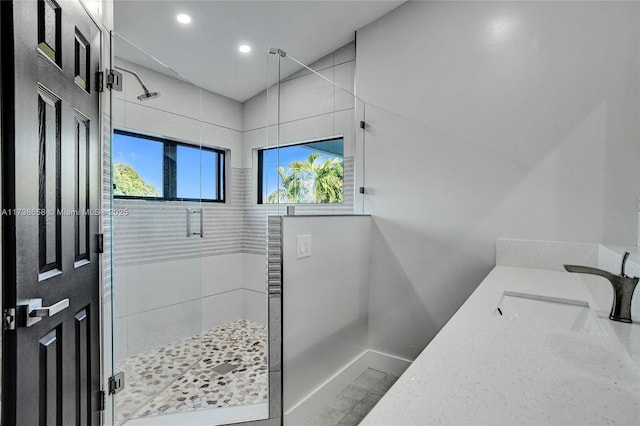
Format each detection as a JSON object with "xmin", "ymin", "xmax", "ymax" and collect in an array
[{"xmin": 306, "ymin": 368, "xmax": 398, "ymax": 426}]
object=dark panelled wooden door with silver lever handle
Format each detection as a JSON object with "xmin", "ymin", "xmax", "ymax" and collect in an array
[{"xmin": 2, "ymin": 0, "xmax": 101, "ymax": 426}]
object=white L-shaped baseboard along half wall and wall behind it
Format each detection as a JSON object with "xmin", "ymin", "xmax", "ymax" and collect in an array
[{"xmin": 284, "ymin": 350, "xmax": 411, "ymax": 426}]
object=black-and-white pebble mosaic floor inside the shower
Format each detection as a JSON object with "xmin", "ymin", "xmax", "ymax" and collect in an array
[{"xmin": 116, "ymin": 320, "xmax": 268, "ymax": 425}]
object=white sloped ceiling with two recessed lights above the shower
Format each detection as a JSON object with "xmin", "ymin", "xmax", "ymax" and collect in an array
[{"xmin": 114, "ymin": 0, "xmax": 404, "ymax": 102}]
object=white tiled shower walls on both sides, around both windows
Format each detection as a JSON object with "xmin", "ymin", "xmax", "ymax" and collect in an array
[{"xmin": 110, "ymin": 43, "xmax": 356, "ymax": 360}]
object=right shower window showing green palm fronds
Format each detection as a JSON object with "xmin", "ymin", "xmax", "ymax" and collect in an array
[{"xmin": 258, "ymin": 138, "xmax": 344, "ymax": 204}]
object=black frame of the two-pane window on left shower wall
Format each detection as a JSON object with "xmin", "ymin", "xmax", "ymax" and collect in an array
[{"xmin": 111, "ymin": 129, "xmax": 228, "ymax": 203}]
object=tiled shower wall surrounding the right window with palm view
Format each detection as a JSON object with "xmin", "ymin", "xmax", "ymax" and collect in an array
[{"xmin": 242, "ymin": 42, "xmax": 361, "ymax": 253}]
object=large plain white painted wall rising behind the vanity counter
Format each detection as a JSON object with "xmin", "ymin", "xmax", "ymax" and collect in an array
[{"xmin": 356, "ymin": 2, "xmax": 640, "ymax": 358}]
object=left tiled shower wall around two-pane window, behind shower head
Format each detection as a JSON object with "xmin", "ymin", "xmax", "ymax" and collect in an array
[{"xmin": 113, "ymin": 55, "xmax": 252, "ymax": 361}]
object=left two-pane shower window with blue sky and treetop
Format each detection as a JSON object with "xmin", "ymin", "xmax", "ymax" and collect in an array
[{"xmin": 112, "ymin": 130, "xmax": 225, "ymax": 202}]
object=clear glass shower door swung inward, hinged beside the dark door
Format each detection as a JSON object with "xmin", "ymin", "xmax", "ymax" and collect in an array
[{"xmin": 111, "ymin": 36, "xmax": 204, "ymax": 425}]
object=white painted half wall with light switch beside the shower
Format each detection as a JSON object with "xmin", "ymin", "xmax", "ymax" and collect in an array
[{"xmin": 282, "ymin": 216, "xmax": 371, "ymax": 413}]
